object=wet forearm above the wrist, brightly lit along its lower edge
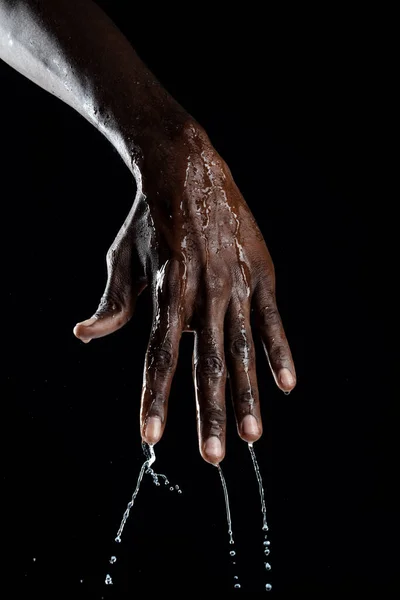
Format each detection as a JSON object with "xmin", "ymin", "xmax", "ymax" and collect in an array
[{"xmin": 0, "ymin": 0, "xmax": 189, "ymax": 173}]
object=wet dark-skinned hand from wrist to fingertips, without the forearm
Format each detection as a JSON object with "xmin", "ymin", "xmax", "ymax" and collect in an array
[{"xmin": 74, "ymin": 121, "xmax": 296, "ymax": 464}]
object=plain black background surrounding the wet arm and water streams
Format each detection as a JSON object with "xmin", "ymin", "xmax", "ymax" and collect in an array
[{"xmin": 0, "ymin": 1, "xmax": 399, "ymax": 598}]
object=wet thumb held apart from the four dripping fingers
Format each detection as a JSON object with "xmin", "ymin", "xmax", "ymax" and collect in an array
[{"xmin": 73, "ymin": 241, "xmax": 147, "ymax": 343}]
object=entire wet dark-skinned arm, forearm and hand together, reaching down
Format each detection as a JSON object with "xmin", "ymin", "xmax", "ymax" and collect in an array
[{"xmin": 0, "ymin": 0, "xmax": 296, "ymax": 464}]
